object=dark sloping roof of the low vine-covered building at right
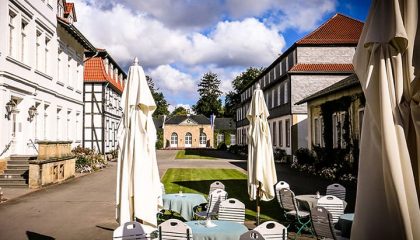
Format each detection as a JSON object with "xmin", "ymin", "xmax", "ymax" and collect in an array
[{"xmin": 296, "ymin": 74, "xmax": 361, "ymax": 105}]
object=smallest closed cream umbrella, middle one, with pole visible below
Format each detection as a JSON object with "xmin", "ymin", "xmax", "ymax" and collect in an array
[{"xmin": 246, "ymin": 84, "xmax": 277, "ymax": 225}]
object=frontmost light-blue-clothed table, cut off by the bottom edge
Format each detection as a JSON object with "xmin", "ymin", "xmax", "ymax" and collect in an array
[{"xmin": 186, "ymin": 220, "xmax": 248, "ymax": 240}]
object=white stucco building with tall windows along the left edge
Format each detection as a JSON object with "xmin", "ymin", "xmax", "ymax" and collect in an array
[{"xmin": 0, "ymin": 0, "xmax": 95, "ymax": 160}]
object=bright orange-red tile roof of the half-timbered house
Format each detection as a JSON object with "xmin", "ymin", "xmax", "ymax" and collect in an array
[{"xmin": 84, "ymin": 57, "xmax": 124, "ymax": 93}]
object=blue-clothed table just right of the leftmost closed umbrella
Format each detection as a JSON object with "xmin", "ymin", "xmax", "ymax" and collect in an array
[{"xmin": 162, "ymin": 193, "xmax": 207, "ymax": 221}]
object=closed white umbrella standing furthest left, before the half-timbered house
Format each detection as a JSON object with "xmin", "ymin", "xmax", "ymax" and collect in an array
[{"xmin": 116, "ymin": 58, "xmax": 162, "ymax": 226}]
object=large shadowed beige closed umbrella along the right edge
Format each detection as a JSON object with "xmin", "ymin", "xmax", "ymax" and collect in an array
[{"xmin": 351, "ymin": 0, "xmax": 420, "ymax": 239}]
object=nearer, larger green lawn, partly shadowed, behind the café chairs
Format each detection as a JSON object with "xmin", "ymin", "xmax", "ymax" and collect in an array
[{"xmin": 162, "ymin": 168, "xmax": 282, "ymax": 221}]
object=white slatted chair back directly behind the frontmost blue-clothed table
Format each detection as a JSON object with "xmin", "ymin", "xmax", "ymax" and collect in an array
[{"xmin": 218, "ymin": 198, "xmax": 245, "ymax": 224}]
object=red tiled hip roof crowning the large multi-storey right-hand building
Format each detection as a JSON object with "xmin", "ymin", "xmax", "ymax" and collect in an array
[{"xmin": 296, "ymin": 13, "xmax": 363, "ymax": 45}]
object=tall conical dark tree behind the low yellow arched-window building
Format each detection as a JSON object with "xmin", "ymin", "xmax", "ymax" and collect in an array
[{"xmin": 192, "ymin": 72, "xmax": 222, "ymax": 116}]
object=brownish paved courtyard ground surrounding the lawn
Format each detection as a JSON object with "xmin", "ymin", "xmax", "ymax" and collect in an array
[{"xmin": 0, "ymin": 150, "xmax": 354, "ymax": 240}]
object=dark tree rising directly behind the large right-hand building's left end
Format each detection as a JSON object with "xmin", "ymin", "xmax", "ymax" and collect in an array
[{"xmin": 224, "ymin": 67, "xmax": 264, "ymax": 117}]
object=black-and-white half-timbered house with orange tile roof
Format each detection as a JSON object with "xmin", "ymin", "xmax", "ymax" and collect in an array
[{"xmin": 83, "ymin": 49, "xmax": 127, "ymax": 153}]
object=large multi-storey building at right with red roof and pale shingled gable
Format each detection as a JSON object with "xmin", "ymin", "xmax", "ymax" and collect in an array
[{"xmin": 236, "ymin": 14, "xmax": 363, "ymax": 155}]
